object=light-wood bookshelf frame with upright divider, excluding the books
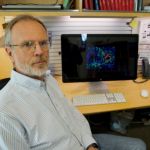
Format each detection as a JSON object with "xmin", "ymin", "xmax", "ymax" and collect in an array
[{"xmin": 0, "ymin": 0, "xmax": 150, "ymax": 17}]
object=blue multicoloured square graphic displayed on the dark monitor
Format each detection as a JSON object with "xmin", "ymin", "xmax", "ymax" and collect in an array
[{"xmin": 86, "ymin": 46, "xmax": 116, "ymax": 70}]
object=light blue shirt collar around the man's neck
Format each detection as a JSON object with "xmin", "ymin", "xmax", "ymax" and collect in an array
[{"xmin": 11, "ymin": 70, "xmax": 50, "ymax": 88}]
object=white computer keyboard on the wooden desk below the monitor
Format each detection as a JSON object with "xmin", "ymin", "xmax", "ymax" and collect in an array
[{"xmin": 73, "ymin": 93, "xmax": 126, "ymax": 106}]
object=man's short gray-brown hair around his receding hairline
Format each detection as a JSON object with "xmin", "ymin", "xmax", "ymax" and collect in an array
[{"xmin": 5, "ymin": 15, "xmax": 47, "ymax": 46}]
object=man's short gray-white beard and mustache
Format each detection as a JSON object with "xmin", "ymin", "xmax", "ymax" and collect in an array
[{"xmin": 15, "ymin": 58, "xmax": 48, "ymax": 77}]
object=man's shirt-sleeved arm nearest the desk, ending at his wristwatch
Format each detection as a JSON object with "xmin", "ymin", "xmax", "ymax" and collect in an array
[{"xmin": 48, "ymin": 76, "xmax": 99, "ymax": 149}]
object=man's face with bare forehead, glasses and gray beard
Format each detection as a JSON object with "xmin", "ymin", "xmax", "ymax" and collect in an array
[{"xmin": 7, "ymin": 21, "xmax": 49, "ymax": 77}]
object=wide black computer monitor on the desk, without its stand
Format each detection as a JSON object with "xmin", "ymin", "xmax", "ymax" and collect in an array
[{"xmin": 61, "ymin": 34, "xmax": 138, "ymax": 82}]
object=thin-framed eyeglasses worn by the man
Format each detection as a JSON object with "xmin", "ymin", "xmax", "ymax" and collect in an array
[{"xmin": 9, "ymin": 40, "xmax": 50, "ymax": 51}]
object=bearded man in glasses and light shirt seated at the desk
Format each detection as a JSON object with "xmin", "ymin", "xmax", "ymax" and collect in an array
[{"xmin": 0, "ymin": 15, "xmax": 146, "ymax": 150}]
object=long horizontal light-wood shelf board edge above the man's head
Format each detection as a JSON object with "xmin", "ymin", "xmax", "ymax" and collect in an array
[{"xmin": 0, "ymin": 10, "xmax": 150, "ymax": 17}]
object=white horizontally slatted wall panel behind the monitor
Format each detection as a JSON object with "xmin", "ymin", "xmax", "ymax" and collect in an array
[{"xmin": 5, "ymin": 16, "xmax": 138, "ymax": 75}]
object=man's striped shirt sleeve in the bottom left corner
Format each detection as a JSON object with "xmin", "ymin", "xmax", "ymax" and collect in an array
[{"xmin": 0, "ymin": 113, "xmax": 30, "ymax": 150}]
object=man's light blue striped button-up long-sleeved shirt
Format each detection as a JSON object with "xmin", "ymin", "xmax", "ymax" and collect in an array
[{"xmin": 0, "ymin": 71, "xmax": 95, "ymax": 150}]
